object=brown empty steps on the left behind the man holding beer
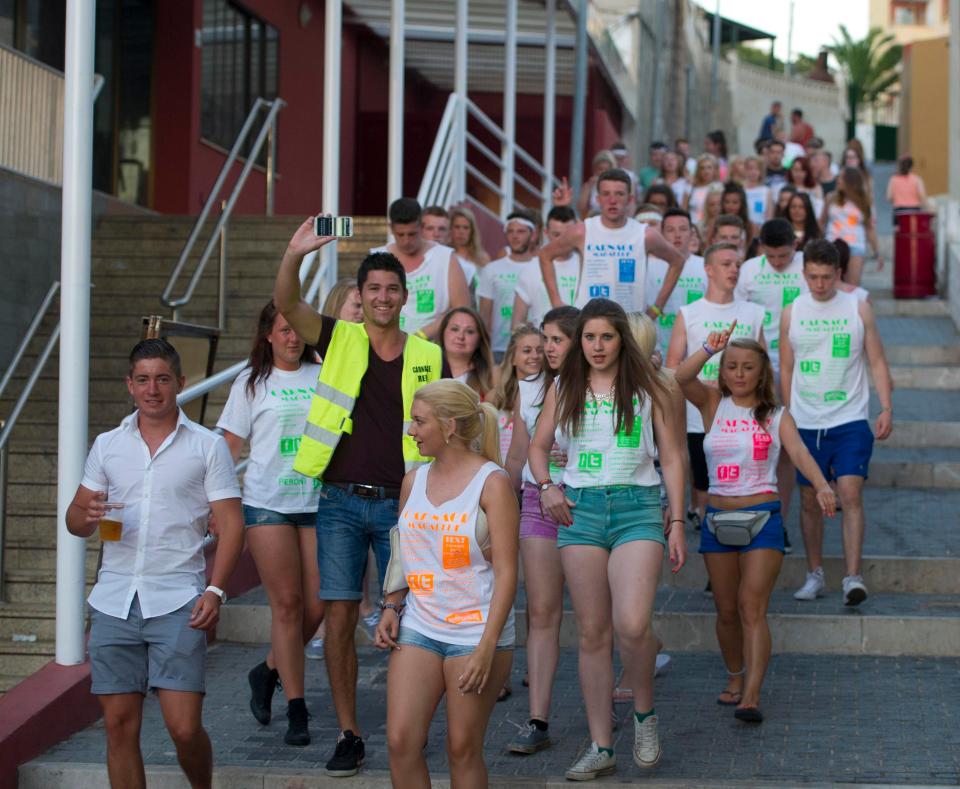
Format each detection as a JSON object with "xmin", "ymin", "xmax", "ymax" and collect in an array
[{"xmin": 0, "ymin": 212, "xmax": 385, "ymax": 693}]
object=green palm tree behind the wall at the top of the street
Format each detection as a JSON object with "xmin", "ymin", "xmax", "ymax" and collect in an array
[{"xmin": 827, "ymin": 25, "xmax": 903, "ymax": 139}]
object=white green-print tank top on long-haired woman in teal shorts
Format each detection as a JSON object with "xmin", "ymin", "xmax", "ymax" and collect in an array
[{"xmin": 563, "ymin": 392, "xmax": 660, "ymax": 488}]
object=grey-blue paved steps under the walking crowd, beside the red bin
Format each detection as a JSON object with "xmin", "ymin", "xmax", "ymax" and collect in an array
[{"xmin": 217, "ymin": 272, "xmax": 960, "ymax": 657}]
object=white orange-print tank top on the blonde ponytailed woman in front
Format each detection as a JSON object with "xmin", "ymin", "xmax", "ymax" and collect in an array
[{"xmin": 399, "ymin": 463, "xmax": 514, "ymax": 646}]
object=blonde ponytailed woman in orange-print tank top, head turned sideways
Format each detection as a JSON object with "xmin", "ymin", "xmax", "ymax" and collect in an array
[{"xmin": 375, "ymin": 380, "xmax": 520, "ymax": 789}]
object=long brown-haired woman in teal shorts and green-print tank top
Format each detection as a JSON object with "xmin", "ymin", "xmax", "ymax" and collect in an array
[{"xmin": 530, "ymin": 299, "xmax": 686, "ymax": 781}]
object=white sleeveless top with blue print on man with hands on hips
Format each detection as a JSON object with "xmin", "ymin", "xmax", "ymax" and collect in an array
[{"xmin": 575, "ymin": 216, "xmax": 647, "ymax": 313}]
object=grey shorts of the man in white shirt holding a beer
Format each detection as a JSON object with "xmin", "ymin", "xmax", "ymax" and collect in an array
[{"xmin": 87, "ymin": 597, "xmax": 207, "ymax": 696}]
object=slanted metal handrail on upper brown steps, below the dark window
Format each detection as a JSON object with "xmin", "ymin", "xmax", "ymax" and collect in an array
[{"xmin": 160, "ymin": 98, "xmax": 286, "ymax": 320}]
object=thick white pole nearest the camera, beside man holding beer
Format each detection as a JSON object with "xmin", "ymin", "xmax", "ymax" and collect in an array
[{"xmin": 56, "ymin": 0, "xmax": 95, "ymax": 666}]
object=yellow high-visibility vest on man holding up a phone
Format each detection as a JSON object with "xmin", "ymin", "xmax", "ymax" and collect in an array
[{"xmin": 293, "ymin": 321, "xmax": 443, "ymax": 482}]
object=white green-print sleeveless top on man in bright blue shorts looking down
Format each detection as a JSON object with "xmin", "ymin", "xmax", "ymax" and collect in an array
[{"xmin": 790, "ymin": 291, "xmax": 870, "ymax": 430}]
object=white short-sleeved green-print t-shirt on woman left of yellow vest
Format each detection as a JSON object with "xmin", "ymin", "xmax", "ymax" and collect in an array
[{"xmin": 217, "ymin": 364, "xmax": 320, "ymax": 513}]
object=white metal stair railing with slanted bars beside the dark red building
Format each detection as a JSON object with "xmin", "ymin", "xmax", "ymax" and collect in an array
[{"xmin": 417, "ymin": 93, "xmax": 560, "ymax": 219}]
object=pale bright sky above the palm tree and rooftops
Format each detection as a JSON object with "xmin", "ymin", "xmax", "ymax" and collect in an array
[{"xmin": 697, "ymin": 0, "xmax": 869, "ymax": 60}]
